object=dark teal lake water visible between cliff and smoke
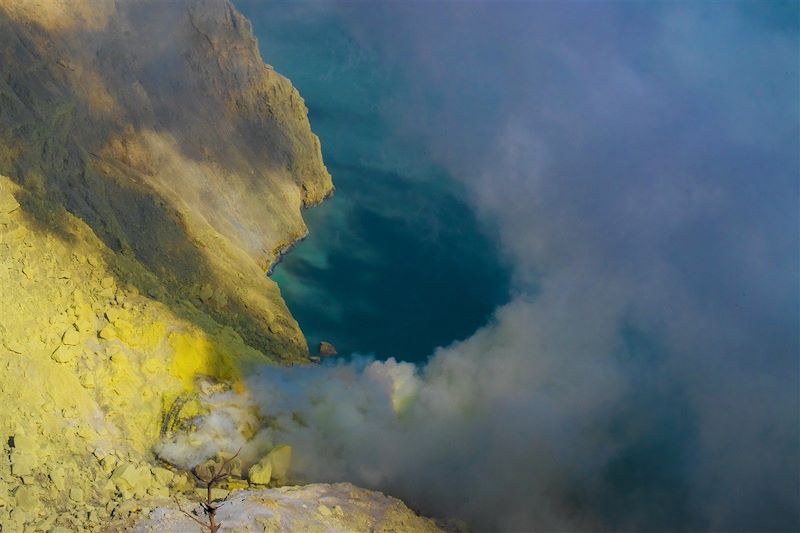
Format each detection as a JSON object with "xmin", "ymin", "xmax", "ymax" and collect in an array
[{"xmin": 237, "ymin": 2, "xmax": 509, "ymax": 362}]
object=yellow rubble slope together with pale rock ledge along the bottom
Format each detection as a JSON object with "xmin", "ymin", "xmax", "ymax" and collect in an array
[{"xmin": 0, "ymin": 175, "xmax": 437, "ymax": 533}]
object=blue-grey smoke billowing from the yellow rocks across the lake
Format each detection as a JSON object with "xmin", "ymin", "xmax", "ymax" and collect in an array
[{"xmin": 163, "ymin": 2, "xmax": 800, "ymax": 531}]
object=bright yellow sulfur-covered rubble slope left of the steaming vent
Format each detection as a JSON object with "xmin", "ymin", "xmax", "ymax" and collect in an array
[{"xmin": 0, "ymin": 176, "xmax": 284, "ymax": 531}]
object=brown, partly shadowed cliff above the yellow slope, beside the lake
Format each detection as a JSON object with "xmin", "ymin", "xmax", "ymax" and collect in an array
[{"xmin": 0, "ymin": 0, "xmax": 333, "ymax": 360}]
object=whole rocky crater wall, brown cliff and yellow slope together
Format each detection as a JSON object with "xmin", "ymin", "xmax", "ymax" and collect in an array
[{"xmin": 0, "ymin": 0, "xmax": 435, "ymax": 532}]
